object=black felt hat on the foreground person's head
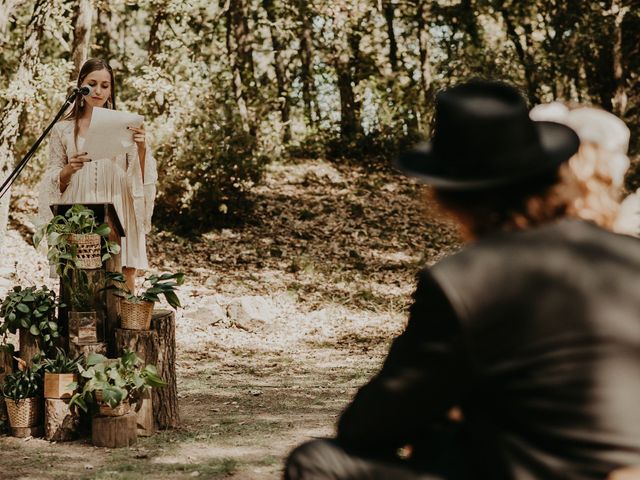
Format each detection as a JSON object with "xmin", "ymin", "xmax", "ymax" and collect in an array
[{"xmin": 395, "ymin": 81, "xmax": 580, "ymax": 190}]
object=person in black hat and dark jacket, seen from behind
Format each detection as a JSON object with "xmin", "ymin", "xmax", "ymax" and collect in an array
[{"xmin": 284, "ymin": 81, "xmax": 640, "ymax": 480}]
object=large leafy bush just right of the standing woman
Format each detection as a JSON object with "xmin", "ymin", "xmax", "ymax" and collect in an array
[{"xmin": 154, "ymin": 97, "xmax": 268, "ymax": 231}]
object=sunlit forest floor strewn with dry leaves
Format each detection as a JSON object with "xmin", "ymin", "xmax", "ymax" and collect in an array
[{"xmin": 0, "ymin": 156, "xmax": 457, "ymax": 480}]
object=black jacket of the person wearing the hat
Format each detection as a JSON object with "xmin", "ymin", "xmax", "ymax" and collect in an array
[{"xmin": 338, "ymin": 220, "xmax": 640, "ymax": 480}]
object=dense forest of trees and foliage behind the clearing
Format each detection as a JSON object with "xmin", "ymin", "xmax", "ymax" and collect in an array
[{"xmin": 0, "ymin": 0, "xmax": 640, "ymax": 235}]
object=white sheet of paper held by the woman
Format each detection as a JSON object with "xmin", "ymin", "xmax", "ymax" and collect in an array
[{"xmin": 82, "ymin": 107, "xmax": 144, "ymax": 160}]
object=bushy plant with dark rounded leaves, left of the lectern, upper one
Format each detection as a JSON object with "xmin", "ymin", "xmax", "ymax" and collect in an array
[{"xmin": 0, "ymin": 286, "xmax": 60, "ymax": 362}]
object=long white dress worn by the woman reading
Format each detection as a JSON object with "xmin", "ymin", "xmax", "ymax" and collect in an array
[{"xmin": 39, "ymin": 120, "xmax": 158, "ymax": 270}]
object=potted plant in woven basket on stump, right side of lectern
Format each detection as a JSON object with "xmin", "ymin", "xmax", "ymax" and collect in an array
[{"xmin": 107, "ymin": 272, "xmax": 184, "ymax": 330}]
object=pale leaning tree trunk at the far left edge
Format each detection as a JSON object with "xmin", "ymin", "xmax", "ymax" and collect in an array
[{"xmin": 0, "ymin": 0, "xmax": 51, "ymax": 251}]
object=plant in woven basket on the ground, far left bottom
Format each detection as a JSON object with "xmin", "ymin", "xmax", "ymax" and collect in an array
[{"xmin": 2, "ymin": 362, "xmax": 42, "ymax": 428}]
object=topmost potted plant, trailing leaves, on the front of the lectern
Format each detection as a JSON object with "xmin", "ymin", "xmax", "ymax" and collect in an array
[{"xmin": 33, "ymin": 205, "xmax": 120, "ymax": 279}]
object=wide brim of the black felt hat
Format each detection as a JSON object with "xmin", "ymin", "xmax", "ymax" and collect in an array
[{"xmin": 394, "ymin": 122, "xmax": 580, "ymax": 190}]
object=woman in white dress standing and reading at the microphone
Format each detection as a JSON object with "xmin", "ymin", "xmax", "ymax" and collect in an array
[{"xmin": 40, "ymin": 58, "xmax": 158, "ymax": 292}]
